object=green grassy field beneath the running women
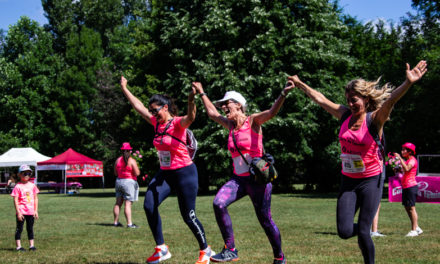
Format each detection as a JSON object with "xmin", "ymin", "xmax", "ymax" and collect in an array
[{"xmin": 0, "ymin": 187, "xmax": 440, "ymax": 264}]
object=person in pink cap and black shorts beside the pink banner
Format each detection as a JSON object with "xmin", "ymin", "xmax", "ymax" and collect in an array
[{"xmin": 394, "ymin": 142, "xmax": 423, "ymax": 237}]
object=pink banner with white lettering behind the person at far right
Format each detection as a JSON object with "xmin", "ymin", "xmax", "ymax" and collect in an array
[{"xmin": 388, "ymin": 176, "xmax": 440, "ymax": 203}]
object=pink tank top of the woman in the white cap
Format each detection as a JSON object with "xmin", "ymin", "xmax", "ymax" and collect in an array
[{"xmin": 228, "ymin": 117, "xmax": 263, "ymax": 176}]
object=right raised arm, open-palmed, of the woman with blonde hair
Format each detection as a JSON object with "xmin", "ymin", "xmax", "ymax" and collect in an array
[{"xmin": 372, "ymin": 60, "xmax": 428, "ymax": 130}]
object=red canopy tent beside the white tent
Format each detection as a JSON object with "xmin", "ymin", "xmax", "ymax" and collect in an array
[{"xmin": 37, "ymin": 148, "xmax": 104, "ymax": 192}]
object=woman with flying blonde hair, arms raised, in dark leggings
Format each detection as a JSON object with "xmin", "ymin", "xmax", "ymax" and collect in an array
[{"xmin": 289, "ymin": 61, "xmax": 427, "ymax": 263}]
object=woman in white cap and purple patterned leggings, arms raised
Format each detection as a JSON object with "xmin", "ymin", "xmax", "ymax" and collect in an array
[{"xmin": 193, "ymin": 82, "xmax": 294, "ymax": 264}]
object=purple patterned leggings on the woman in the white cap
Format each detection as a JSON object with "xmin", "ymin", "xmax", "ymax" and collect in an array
[{"xmin": 214, "ymin": 175, "xmax": 284, "ymax": 258}]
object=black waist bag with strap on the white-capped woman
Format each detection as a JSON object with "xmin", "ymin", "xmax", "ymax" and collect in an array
[{"xmin": 231, "ymin": 131, "xmax": 278, "ymax": 184}]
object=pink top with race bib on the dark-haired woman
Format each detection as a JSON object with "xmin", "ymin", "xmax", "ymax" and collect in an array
[{"xmin": 150, "ymin": 116, "xmax": 193, "ymax": 170}]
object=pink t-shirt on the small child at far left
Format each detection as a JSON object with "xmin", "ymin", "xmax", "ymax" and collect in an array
[{"xmin": 11, "ymin": 182, "xmax": 40, "ymax": 215}]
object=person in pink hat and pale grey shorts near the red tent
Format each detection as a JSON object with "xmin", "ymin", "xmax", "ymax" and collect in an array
[{"xmin": 113, "ymin": 142, "xmax": 140, "ymax": 228}]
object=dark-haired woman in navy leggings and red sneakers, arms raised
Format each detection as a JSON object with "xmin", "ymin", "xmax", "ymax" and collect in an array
[{"xmin": 121, "ymin": 76, "xmax": 214, "ymax": 264}]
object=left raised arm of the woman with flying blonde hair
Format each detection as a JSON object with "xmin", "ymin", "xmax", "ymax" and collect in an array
[{"xmin": 288, "ymin": 75, "xmax": 348, "ymax": 120}]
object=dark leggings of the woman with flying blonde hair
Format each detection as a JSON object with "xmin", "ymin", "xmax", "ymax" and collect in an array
[{"xmin": 336, "ymin": 174, "xmax": 383, "ymax": 263}]
